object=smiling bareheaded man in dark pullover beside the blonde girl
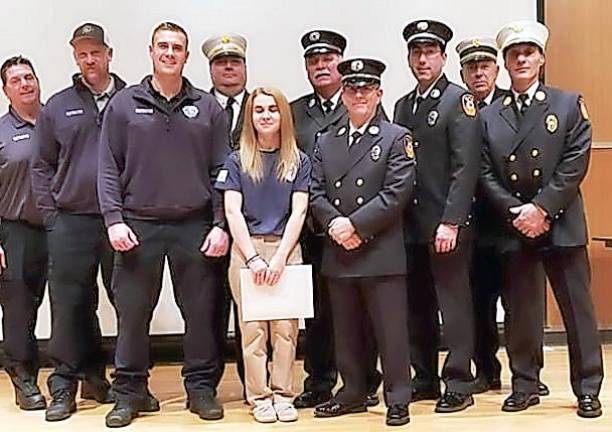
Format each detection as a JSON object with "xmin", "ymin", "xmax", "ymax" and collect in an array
[{"xmin": 98, "ymin": 23, "xmax": 229, "ymax": 427}]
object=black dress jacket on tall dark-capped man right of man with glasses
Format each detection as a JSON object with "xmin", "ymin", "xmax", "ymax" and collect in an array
[{"xmin": 393, "ymin": 75, "xmax": 481, "ymax": 243}]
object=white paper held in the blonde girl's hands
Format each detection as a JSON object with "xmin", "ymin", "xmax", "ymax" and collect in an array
[{"xmin": 240, "ymin": 265, "xmax": 314, "ymax": 321}]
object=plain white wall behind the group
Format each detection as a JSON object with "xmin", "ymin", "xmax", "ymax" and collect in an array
[{"xmin": 0, "ymin": 0, "xmax": 536, "ymax": 338}]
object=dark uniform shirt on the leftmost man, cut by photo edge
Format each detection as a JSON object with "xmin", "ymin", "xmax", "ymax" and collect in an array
[{"xmin": 0, "ymin": 108, "xmax": 42, "ymax": 225}]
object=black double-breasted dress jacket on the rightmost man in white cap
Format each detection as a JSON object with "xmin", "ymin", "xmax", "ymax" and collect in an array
[{"xmin": 480, "ymin": 85, "xmax": 591, "ymax": 250}]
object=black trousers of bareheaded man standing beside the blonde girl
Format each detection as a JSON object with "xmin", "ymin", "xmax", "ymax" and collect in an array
[{"xmin": 113, "ymin": 220, "xmax": 222, "ymax": 399}]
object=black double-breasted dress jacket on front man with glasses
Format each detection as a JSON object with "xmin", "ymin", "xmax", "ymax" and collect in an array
[{"xmin": 311, "ymin": 117, "xmax": 415, "ymax": 278}]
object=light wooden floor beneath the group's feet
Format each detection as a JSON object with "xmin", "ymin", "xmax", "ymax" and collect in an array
[{"xmin": 0, "ymin": 345, "xmax": 612, "ymax": 432}]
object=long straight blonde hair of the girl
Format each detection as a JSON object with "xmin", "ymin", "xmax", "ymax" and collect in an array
[{"xmin": 240, "ymin": 87, "xmax": 300, "ymax": 182}]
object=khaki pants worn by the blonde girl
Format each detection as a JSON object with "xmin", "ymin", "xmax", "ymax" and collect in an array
[{"xmin": 229, "ymin": 236, "xmax": 302, "ymax": 406}]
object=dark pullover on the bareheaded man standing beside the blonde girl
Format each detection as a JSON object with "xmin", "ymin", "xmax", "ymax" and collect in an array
[{"xmin": 98, "ymin": 76, "xmax": 229, "ymax": 226}]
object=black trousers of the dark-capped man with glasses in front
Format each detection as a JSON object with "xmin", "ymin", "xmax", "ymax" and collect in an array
[{"xmin": 327, "ymin": 276, "xmax": 411, "ymax": 406}]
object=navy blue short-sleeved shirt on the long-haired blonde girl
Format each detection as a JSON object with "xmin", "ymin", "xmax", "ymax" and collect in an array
[{"xmin": 215, "ymin": 150, "xmax": 311, "ymax": 236}]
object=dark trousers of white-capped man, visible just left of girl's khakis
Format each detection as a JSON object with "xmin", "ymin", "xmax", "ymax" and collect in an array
[{"xmin": 215, "ymin": 255, "xmax": 244, "ymax": 387}]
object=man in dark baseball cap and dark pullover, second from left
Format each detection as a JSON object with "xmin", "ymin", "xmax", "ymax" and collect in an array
[{"xmin": 32, "ymin": 23, "xmax": 125, "ymax": 421}]
